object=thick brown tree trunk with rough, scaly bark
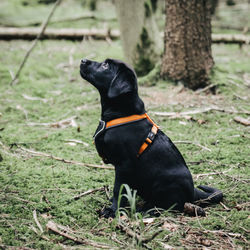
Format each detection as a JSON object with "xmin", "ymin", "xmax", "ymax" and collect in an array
[{"xmin": 161, "ymin": 0, "xmax": 214, "ymax": 89}]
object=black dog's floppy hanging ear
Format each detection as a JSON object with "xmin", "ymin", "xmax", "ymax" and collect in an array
[{"xmin": 108, "ymin": 65, "xmax": 137, "ymax": 98}]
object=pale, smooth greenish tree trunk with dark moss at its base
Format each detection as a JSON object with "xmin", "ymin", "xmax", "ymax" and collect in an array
[{"xmin": 115, "ymin": 0, "xmax": 162, "ymax": 75}]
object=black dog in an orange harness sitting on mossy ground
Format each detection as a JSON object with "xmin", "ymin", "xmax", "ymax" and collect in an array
[{"xmin": 80, "ymin": 59, "xmax": 223, "ymax": 217}]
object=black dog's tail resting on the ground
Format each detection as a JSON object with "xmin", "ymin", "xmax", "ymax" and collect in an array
[{"xmin": 194, "ymin": 185, "xmax": 223, "ymax": 207}]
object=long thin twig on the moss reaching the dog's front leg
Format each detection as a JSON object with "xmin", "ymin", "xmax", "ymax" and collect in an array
[{"xmin": 17, "ymin": 146, "xmax": 114, "ymax": 170}]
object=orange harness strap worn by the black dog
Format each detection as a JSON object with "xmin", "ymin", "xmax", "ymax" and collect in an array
[{"xmin": 94, "ymin": 113, "xmax": 159, "ymax": 157}]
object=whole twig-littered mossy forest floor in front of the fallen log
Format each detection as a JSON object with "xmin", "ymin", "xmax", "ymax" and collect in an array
[{"xmin": 0, "ymin": 1, "xmax": 250, "ymax": 249}]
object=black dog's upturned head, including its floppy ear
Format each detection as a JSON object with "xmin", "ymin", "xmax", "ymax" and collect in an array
[{"xmin": 80, "ymin": 59, "xmax": 137, "ymax": 98}]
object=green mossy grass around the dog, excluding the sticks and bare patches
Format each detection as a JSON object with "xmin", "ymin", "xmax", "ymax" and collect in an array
[{"xmin": 0, "ymin": 38, "xmax": 250, "ymax": 249}]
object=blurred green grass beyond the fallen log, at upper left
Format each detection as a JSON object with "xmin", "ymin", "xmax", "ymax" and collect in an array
[{"xmin": 0, "ymin": 0, "xmax": 118, "ymax": 28}]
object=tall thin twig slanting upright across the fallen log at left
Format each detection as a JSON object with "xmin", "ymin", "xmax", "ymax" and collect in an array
[{"xmin": 10, "ymin": 0, "xmax": 62, "ymax": 85}]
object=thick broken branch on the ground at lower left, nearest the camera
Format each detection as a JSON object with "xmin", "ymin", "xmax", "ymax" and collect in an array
[{"xmin": 46, "ymin": 220, "xmax": 112, "ymax": 249}]
